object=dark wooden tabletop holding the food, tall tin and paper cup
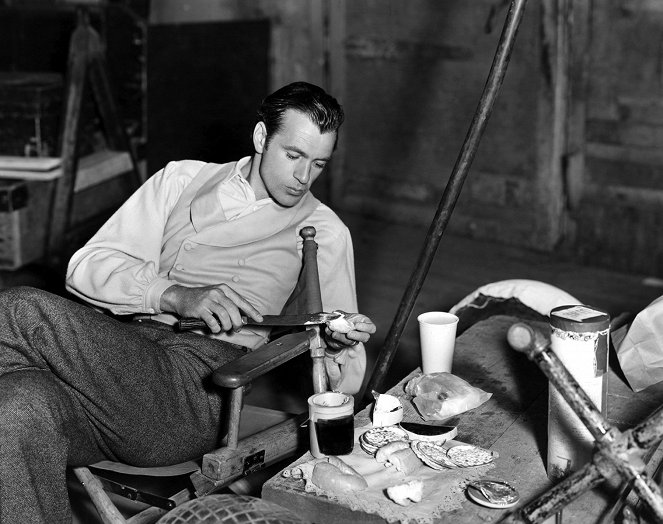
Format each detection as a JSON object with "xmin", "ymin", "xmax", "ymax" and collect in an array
[{"xmin": 262, "ymin": 316, "xmax": 663, "ymax": 524}]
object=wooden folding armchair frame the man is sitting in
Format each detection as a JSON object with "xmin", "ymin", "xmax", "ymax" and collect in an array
[{"xmin": 74, "ymin": 227, "xmax": 327, "ymax": 524}]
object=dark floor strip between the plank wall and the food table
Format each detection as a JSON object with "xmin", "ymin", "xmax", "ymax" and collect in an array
[{"xmin": 343, "ymin": 211, "xmax": 663, "ymax": 396}]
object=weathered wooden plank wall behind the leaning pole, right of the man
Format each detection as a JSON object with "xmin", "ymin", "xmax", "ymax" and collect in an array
[{"xmin": 332, "ymin": 0, "xmax": 663, "ymax": 277}]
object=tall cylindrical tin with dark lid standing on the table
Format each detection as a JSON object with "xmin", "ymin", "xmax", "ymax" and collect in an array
[{"xmin": 547, "ymin": 305, "xmax": 610, "ymax": 480}]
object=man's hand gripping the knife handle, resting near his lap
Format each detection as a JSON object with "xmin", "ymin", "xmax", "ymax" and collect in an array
[{"xmin": 160, "ymin": 284, "xmax": 262, "ymax": 333}]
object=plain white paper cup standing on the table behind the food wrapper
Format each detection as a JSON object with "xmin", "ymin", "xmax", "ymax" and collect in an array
[{"xmin": 417, "ymin": 311, "xmax": 458, "ymax": 374}]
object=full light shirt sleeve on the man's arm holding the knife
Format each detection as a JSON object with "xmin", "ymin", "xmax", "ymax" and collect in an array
[{"xmin": 66, "ymin": 162, "xmax": 200, "ymax": 315}]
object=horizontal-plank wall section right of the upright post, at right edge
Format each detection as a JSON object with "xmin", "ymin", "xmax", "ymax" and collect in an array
[{"xmin": 566, "ymin": 0, "xmax": 663, "ymax": 276}]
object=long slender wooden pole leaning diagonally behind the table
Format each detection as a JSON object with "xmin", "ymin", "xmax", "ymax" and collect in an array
[{"xmin": 364, "ymin": 0, "xmax": 527, "ymax": 401}]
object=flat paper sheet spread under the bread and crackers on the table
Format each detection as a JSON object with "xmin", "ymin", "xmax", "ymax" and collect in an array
[{"xmin": 284, "ymin": 426, "xmax": 495, "ymax": 524}]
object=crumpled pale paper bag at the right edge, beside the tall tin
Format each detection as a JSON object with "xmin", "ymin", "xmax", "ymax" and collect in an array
[{"xmin": 613, "ymin": 297, "xmax": 663, "ymax": 391}]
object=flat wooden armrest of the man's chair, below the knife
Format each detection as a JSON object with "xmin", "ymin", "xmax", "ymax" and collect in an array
[{"xmin": 212, "ymin": 329, "xmax": 316, "ymax": 389}]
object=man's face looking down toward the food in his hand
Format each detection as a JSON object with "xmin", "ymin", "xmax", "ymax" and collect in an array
[{"xmin": 254, "ymin": 109, "xmax": 336, "ymax": 207}]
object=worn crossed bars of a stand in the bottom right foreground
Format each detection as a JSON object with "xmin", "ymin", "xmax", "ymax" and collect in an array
[{"xmin": 502, "ymin": 323, "xmax": 663, "ymax": 523}]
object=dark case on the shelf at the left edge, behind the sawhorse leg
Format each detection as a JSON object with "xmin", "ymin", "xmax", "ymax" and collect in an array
[{"xmin": 0, "ymin": 72, "xmax": 63, "ymax": 156}]
